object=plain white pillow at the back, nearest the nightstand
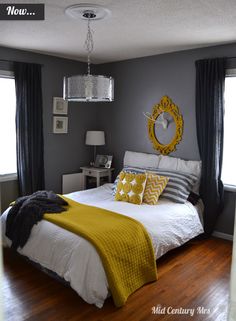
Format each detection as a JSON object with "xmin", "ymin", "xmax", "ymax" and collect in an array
[{"xmin": 124, "ymin": 151, "xmax": 160, "ymax": 168}]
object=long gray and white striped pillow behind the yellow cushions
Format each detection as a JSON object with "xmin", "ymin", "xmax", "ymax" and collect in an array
[{"xmin": 113, "ymin": 167, "xmax": 197, "ymax": 204}]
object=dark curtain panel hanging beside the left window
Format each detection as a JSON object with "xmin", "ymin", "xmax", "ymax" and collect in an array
[{"xmin": 14, "ymin": 62, "xmax": 44, "ymax": 195}]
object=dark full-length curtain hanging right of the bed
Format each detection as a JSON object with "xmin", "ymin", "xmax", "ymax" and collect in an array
[{"xmin": 196, "ymin": 58, "xmax": 225, "ymax": 235}]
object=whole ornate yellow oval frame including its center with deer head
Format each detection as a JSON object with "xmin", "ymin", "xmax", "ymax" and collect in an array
[{"xmin": 148, "ymin": 96, "xmax": 183, "ymax": 155}]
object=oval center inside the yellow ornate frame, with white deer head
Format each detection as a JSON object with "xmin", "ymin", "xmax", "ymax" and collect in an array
[{"xmin": 155, "ymin": 112, "xmax": 176, "ymax": 145}]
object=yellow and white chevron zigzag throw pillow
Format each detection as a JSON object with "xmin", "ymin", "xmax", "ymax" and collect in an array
[{"xmin": 143, "ymin": 173, "xmax": 169, "ymax": 205}]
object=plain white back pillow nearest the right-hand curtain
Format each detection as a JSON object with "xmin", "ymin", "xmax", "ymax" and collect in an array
[{"xmin": 159, "ymin": 155, "xmax": 202, "ymax": 194}]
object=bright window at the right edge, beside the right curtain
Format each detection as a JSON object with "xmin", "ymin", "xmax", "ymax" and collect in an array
[{"xmin": 221, "ymin": 69, "xmax": 236, "ymax": 187}]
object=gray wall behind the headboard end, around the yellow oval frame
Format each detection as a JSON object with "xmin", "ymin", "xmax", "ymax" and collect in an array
[{"xmin": 97, "ymin": 44, "xmax": 236, "ymax": 234}]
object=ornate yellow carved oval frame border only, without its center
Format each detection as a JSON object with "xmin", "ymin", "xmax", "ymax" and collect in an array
[{"xmin": 148, "ymin": 96, "xmax": 184, "ymax": 155}]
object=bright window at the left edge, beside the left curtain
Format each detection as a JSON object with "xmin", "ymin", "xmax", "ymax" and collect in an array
[{"xmin": 0, "ymin": 70, "xmax": 17, "ymax": 177}]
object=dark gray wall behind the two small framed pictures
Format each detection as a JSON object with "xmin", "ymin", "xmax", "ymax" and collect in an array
[{"xmin": 0, "ymin": 47, "xmax": 97, "ymax": 193}]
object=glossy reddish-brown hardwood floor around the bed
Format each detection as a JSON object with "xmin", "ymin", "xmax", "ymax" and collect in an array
[{"xmin": 3, "ymin": 238, "xmax": 232, "ymax": 321}]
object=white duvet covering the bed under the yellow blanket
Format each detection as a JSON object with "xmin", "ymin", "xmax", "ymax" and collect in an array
[{"xmin": 1, "ymin": 184, "xmax": 203, "ymax": 308}]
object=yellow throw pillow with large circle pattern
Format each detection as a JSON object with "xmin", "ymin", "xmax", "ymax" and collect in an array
[{"xmin": 115, "ymin": 172, "xmax": 147, "ymax": 204}]
